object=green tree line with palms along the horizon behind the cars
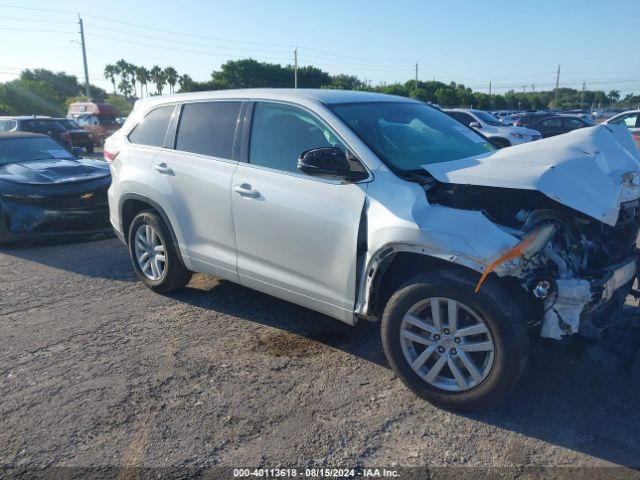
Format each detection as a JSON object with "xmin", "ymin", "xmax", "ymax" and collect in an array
[{"xmin": 0, "ymin": 59, "xmax": 640, "ymax": 116}]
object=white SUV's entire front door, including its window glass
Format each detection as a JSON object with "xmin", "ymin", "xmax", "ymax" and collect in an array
[{"xmin": 231, "ymin": 102, "xmax": 366, "ymax": 322}]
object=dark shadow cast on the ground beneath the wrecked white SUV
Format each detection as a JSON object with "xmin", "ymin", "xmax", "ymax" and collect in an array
[{"xmin": 172, "ymin": 277, "xmax": 640, "ymax": 466}]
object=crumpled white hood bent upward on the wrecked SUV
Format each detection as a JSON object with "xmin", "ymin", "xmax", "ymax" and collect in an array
[{"xmin": 423, "ymin": 125, "xmax": 640, "ymax": 226}]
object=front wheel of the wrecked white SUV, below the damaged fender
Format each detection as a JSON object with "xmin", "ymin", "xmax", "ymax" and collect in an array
[{"xmin": 382, "ymin": 269, "xmax": 529, "ymax": 412}]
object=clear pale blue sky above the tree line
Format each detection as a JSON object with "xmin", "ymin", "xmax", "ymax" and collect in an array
[{"xmin": 0, "ymin": 0, "xmax": 640, "ymax": 94}]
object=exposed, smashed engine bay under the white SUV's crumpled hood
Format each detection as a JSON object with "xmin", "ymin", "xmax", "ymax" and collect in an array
[{"xmin": 427, "ymin": 182, "xmax": 640, "ymax": 340}]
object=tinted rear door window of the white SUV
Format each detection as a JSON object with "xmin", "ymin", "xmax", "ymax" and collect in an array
[{"xmin": 176, "ymin": 101, "xmax": 240, "ymax": 159}]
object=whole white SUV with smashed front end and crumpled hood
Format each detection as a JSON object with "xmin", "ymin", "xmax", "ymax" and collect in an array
[{"xmin": 105, "ymin": 90, "xmax": 640, "ymax": 410}]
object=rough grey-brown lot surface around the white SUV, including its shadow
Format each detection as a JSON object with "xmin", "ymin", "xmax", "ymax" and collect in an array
[{"xmin": 0, "ymin": 239, "xmax": 640, "ymax": 474}]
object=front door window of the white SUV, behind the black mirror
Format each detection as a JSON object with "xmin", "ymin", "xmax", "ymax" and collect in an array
[{"xmin": 249, "ymin": 102, "xmax": 346, "ymax": 172}]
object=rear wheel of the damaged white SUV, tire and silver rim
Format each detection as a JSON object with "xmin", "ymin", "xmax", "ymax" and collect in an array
[{"xmin": 127, "ymin": 210, "xmax": 192, "ymax": 293}]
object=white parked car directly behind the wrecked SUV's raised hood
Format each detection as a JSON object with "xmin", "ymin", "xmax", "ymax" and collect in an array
[{"xmin": 444, "ymin": 108, "xmax": 542, "ymax": 148}]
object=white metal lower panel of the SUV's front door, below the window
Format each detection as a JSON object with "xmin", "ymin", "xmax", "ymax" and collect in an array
[{"xmin": 231, "ymin": 164, "xmax": 368, "ymax": 323}]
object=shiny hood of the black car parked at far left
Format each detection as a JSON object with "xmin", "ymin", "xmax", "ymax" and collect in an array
[{"xmin": 0, "ymin": 158, "xmax": 110, "ymax": 185}]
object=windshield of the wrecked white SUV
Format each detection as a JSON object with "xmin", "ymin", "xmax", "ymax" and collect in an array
[{"xmin": 328, "ymin": 102, "xmax": 495, "ymax": 172}]
